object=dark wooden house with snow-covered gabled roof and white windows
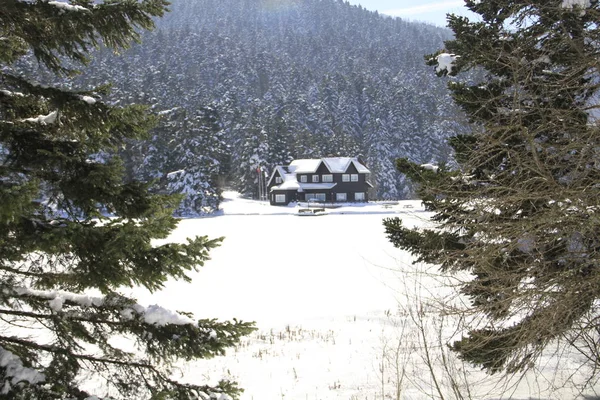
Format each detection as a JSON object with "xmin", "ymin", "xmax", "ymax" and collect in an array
[{"xmin": 267, "ymin": 157, "xmax": 373, "ymax": 206}]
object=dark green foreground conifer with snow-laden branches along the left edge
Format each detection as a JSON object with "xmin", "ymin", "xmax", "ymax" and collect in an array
[{"xmin": 0, "ymin": 0, "xmax": 253, "ymax": 399}]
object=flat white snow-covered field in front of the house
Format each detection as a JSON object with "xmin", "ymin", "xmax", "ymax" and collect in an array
[{"xmin": 135, "ymin": 193, "xmax": 596, "ymax": 400}]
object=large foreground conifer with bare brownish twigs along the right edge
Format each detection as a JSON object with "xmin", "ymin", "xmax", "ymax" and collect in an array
[{"xmin": 385, "ymin": 0, "xmax": 600, "ymax": 375}]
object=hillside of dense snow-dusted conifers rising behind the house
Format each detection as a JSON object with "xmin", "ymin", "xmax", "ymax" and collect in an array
[{"xmin": 27, "ymin": 0, "xmax": 466, "ymax": 212}]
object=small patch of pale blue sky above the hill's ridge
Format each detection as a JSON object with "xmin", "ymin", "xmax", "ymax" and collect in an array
[{"xmin": 348, "ymin": 0, "xmax": 473, "ymax": 26}]
